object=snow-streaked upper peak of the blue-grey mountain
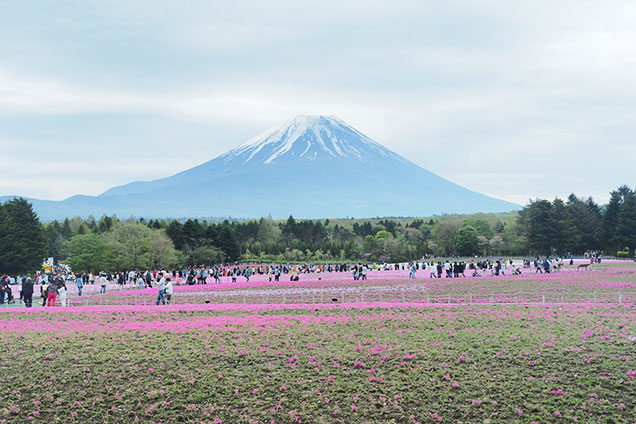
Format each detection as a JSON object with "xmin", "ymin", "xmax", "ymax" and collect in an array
[{"xmin": 221, "ymin": 115, "xmax": 404, "ymax": 165}]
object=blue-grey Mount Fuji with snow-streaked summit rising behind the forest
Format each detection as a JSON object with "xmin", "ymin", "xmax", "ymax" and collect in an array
[{"xmin": 2, "ymin": 115, "xmax": 519, "ymax": 220}]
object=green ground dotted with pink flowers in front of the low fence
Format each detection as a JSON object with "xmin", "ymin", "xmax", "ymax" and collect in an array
[{"xmin": 0, "ymin": 270, "xmax": 636, "ymax": 423}]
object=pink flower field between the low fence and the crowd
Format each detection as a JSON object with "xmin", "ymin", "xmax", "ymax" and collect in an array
[{"xmin": 53, "ymin": 267, "xmax": 636, "ymax": 306}]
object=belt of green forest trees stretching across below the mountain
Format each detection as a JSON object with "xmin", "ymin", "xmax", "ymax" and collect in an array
[{"xmin": 0, "ymin": 186, "xmax": 636, "ymax": 273}]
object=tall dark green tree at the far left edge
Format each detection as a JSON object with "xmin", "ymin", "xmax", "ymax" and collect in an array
[{"xmin": 0, "ymin": 198, "xmax": 47, "ymax": 274}]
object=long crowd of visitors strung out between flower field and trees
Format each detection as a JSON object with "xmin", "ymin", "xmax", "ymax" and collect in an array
[{"xmin": 0, "ymin": 252, "xmax": 601, "ymax": 307}]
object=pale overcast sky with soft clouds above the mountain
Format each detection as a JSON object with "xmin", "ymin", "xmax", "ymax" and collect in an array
[{"xmin": 0, "ymin": 0, "xmax": 636, "ymax": 204}]
